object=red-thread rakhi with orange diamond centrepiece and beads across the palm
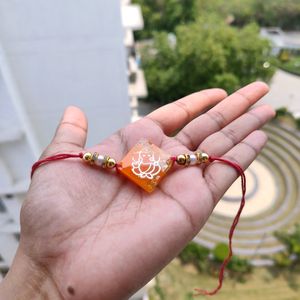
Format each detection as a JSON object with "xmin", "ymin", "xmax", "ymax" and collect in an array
[{"xmin": 31, "ymin": 140, "xmax": 246, "ymax": 296}]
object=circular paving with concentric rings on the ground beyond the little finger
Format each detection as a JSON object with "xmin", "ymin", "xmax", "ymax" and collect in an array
[{"xmin": 195, "ymin": 124, "xmax": 300, "ymax": 258}]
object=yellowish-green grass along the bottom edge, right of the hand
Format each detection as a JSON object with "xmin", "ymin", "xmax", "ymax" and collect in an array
[{"xmin": 149, "ymin": 259, "xmax": 300, "ymax": 300}]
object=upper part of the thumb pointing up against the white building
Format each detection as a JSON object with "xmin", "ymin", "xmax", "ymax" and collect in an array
[{"xmin": 49, "ymin": 106, "xmax": 88, "ymax": 150}]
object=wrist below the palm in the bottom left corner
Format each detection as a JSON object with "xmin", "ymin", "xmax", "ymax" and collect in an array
[{"xmin": 0, "ymin": 247, "xmax": 63, "ymax": 300}]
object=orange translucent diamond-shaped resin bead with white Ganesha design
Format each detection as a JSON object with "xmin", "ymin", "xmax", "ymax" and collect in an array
[{"xmin": 118, "ymin": 140, "xmax": 173, "ymax": 193}]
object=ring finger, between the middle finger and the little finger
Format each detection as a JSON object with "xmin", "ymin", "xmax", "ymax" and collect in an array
[{"xmin": 199, "ymin": 105, "xmax": 275, "ymax": 156}]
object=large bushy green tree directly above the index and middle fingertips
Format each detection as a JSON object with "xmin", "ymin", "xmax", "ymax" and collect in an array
[{"xmin": 142, "ymin": 14, "xmax": 274, "ymax": 103}]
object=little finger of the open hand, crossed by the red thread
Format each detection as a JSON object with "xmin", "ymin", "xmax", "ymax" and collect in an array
[{"xmin": 204, "ymin": 131, "xmax": 267, "ymax": 205}]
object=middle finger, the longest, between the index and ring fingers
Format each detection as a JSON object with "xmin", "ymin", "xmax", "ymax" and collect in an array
[{"xmin": 176, "ymin": 82, "xmax": 269, "ymax": 150}]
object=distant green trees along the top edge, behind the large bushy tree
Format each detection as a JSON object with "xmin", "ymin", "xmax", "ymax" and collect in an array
[{"xmin": 133, "ymin": 0, "xmax": 300, "ymax": 39}]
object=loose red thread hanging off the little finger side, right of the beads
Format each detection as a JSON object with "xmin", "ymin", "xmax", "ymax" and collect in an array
[{"xmin": 194, "ymin": 157, "xmax": 246, "ymax": 296}]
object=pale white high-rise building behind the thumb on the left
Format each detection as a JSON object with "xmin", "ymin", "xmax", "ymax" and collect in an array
[{"xmin": 0, "ymin": 0, "xmax": 146, "ymax": 298}]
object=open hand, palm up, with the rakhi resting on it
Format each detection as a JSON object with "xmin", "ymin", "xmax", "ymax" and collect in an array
[{"xmin": 0, "ymin": 82, "xmax": 274, "ymax": 300}]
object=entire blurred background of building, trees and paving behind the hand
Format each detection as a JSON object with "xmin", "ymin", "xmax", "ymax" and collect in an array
[{"xmin": 0, "ymin": 0, "xmax": 300, "ymax": 300}]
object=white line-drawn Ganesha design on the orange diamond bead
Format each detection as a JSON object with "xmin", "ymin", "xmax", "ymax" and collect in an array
[{"xmin": 131, "ymin": 148, "xmax": 162, "ymax": 179}]
